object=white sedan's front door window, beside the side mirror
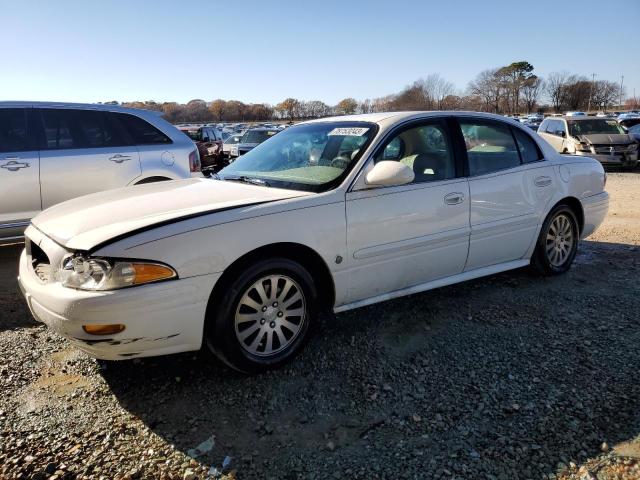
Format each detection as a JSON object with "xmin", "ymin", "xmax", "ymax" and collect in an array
[{"xmin": 375, "ymin": 123, "xmax": 456, "ymax": 183}]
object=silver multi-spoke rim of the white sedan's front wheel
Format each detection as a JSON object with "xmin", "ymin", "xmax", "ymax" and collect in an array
[{"xmin": 235, "ymin": 275, "xmax": 306, "ymax": 356}]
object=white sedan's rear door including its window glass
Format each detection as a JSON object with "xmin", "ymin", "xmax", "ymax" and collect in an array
[{"xmin": 459, "ymin": 117, "xmax": 555, "ymax": 271}]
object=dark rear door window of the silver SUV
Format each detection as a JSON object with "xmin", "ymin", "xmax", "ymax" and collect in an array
[{"xmin": 42, "ymin": 109, "xmax": 126, "ymax": 149}]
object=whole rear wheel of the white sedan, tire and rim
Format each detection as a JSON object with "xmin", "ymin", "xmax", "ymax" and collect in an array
[{"xmin": 531, "ymin": 205, "xmax": 579, "ymax": 275}]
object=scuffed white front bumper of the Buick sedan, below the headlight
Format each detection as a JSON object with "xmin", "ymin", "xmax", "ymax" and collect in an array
[{"xmin": 18, "ymin": 251, "xmax": 219, "ymax": 360}]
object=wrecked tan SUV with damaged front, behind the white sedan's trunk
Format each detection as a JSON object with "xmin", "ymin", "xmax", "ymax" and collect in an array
[{"xmin": 538, "ymin": 116, "xmax": 638, "ymax": 168}]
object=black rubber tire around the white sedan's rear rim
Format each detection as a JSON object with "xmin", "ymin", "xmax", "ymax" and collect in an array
[{"xmin": 531, "ymin": 204, "xmax": 580, "ymax": 275}]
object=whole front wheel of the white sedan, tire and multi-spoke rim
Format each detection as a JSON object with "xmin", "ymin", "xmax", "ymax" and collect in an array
[{"xmin": 205, "ymin": 258, "xmax": 317, "ymax": 373}]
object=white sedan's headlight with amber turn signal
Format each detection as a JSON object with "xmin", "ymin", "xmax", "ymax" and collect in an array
[{"xmin": 56, "ymin": 255, "xmax": 178, "ymax": 290}]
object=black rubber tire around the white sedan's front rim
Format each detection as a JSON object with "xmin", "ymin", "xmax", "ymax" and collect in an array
[{"xmin": 205, "ymin": 258, "xmax": 318, "ymax": 374}]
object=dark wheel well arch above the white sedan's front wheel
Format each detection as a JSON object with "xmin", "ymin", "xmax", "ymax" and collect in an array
[{"xmin": 209, "ymin": 242, "xmax": 335, "ymax": 309}]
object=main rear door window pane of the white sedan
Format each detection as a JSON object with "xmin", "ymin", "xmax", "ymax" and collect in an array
[{"xmin": 460, "ymin": 121, "xmax": 520, "ymax": 176}]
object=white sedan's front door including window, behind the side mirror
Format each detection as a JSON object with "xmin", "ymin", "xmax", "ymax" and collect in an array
[{"xmin": 346, "ymin": 121, "xmax": 469, "ymax": 302}]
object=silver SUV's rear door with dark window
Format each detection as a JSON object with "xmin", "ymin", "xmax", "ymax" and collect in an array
[{"xmin": 40, "ymin": 108, "xmax": 141, "ymax": 208}]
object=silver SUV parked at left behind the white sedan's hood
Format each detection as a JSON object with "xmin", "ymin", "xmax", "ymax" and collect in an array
[{"xmin": 0, "ymin": 102, "xmax": 201, "ymax": 243}]
